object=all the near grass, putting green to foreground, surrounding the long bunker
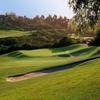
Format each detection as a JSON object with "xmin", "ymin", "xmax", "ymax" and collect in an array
[{"xmin": 0, "ymin": 44, "xmax": 100, "ymax": 100}]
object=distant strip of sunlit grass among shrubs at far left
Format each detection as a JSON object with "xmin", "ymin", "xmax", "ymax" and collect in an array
[{"xmin": 0, "ymin": 30, "xmax": 29, "ymax": 38}]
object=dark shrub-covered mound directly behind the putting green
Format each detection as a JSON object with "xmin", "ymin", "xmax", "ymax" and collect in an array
[{"xmin": 0, "ymin": 30, "xmax": 73, "ymax": 54}]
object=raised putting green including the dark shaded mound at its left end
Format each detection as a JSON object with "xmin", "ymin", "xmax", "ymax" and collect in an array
[{"xmin": 7, "ymin": 44, "xmax": 88, "ymax": 57}]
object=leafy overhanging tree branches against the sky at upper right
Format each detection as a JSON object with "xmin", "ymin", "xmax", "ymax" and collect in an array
[{"xmin": 69, "ymin": 0, "xmax": 100, "ymax": 31}]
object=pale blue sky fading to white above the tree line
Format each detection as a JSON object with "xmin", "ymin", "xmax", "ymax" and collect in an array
[{"xmin": 0, "ymin": 0, "xmax": 73, "ymax": 18}]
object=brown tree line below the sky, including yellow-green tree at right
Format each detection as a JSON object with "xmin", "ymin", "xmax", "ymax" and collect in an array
[{"xmin": 0, "ymin": 13, "xmax": 100, "ymax": 36}]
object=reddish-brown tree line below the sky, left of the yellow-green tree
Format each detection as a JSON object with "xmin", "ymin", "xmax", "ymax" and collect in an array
[{"xmin": 0, "ymin": 13, "xmax": 69, "ymax": 31}]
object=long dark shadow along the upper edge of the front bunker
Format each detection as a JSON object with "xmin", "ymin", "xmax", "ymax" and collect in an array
[{"xmin": 9, "ymin": 55, "xmax": 100, "ymax": 78}]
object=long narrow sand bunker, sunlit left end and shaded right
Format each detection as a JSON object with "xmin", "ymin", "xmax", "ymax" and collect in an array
[{"xmin": 6, "ymin": 56, "xmax": 100, "ymax": 82}]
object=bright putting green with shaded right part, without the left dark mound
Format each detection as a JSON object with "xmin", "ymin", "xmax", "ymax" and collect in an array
[{"xmin": 19, "ymin": 44, "xmax": 87, "ymax": 56}]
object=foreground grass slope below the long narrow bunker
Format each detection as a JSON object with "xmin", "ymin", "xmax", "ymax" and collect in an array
[{"xmin": 0, "ymin": 59, "xmax": 100, "ymax": 100}]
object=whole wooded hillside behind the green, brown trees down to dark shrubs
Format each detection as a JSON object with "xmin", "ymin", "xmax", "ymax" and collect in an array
[{"xmin": 0, "ymin": 13, "xmax": 99, "ymax": 54}]
